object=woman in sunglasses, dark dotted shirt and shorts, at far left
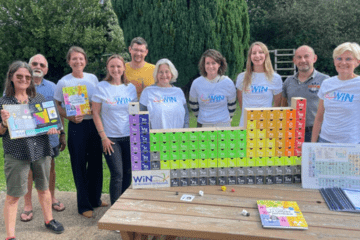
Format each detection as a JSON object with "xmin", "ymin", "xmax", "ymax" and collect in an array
[{"xmin": 0, "ymin": 61, "xmax": 64, "ymax": 239}]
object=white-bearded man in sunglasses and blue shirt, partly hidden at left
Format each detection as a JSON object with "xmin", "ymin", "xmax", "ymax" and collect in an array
[{"xmin": 20, "ymin": 54, "xmax": 66, "ymax": 222}]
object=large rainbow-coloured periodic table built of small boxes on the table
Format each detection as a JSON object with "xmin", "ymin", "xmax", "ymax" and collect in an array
[{"xmin": 129, "ymin": 98, "xmax": 306, "ymax": 188}]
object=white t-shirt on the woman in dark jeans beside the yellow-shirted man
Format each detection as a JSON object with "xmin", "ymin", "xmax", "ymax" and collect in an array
[{"xmin": 91, "ymin": 81, "xmax": 137, "ymax": 138}]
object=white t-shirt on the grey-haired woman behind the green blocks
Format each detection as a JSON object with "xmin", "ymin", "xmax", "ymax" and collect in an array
[{"xmin": 140, "ymin": 85, "xmax": 186, "ymax": 129}]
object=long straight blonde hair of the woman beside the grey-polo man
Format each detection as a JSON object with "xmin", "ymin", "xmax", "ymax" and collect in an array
[{"xmin": 243, "ymin": 42, "xmax": 274, "ymax": 92}]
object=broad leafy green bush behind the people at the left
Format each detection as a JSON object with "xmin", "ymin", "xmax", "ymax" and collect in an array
[{"xmin": 0, "ymin": 0, "xmax": 125, "ymax": 91}]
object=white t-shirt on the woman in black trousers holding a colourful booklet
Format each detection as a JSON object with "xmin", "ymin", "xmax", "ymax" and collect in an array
[{"xmin": 54, "ymin": 72, "xmax": 99, "ymax": 119}]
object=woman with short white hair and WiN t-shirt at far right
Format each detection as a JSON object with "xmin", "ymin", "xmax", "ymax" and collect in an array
[{"xmin": 311, "ymin": 42, "xmax": 360, "ymax": 143}]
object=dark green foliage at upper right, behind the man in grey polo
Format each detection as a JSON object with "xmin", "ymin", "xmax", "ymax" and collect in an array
[{"xmin": 248, "ymin": 0, "xmax": 360, "ymax": 76}]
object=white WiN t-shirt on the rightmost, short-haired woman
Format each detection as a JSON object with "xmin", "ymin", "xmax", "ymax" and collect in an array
[{"xmin": 318, "ymin": 76, "xmax": 360, "ymax": 143}]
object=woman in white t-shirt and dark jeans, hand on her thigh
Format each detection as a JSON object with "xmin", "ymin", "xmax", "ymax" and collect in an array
[{"xmin": 92, "ymin": 54, "xmax": 137, "ymax": 205}]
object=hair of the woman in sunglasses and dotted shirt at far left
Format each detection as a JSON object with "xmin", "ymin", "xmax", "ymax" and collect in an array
[{"xmin": 4, "ymin": 61, "xmax": 36, "ymax": 98}]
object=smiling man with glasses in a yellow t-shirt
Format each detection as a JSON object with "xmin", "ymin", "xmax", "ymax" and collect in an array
[{"xmin": 125, "ymin": 37, "xmax": 155, "ymax": 99}]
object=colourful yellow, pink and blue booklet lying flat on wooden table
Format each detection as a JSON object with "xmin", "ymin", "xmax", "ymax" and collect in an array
[{"xmin": 257, "ymin": 200, "xmax": 308, "ymax": 229}]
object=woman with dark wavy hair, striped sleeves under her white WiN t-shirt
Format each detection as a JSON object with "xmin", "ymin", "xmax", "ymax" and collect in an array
[{"xmin": 189, "ymin": 49, "xmax": 236, "ymax": 127}]
